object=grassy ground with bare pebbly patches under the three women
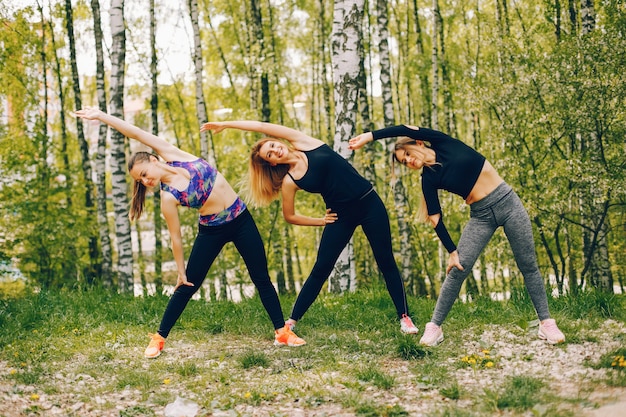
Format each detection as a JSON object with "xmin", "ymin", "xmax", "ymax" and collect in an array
[{"xmin": 0, "ymin": 282, "xmax": 626, "ymax": 417}]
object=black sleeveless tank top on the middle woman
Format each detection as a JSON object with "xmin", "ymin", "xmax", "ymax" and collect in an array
[{"xmin": 289, "ymin": 144, "xmax": 372, "ymax": 208}]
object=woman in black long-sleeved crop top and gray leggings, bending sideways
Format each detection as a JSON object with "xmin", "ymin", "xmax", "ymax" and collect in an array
[{"xmin": 349, "ymin": 125, "xmax": 565, "ymax": 346}]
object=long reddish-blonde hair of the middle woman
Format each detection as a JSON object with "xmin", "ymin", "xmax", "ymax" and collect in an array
[{"xmin": 243, "ymin": 138, "xmax": 289, "ymax": 207}]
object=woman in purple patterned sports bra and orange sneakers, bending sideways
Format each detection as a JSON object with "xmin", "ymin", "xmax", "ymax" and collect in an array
[{"xmin": 75, "ymin": 108, "xmax": 305, "ymax": 358}]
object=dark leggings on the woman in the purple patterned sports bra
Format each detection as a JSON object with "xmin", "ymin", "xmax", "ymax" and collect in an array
[{"xmin": 159, "ymin": 210, "xmax": 285, "ymax": 337}]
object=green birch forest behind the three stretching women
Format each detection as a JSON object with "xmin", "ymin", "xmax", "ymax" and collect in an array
[{"xmin": 0, "ymin": 0, "xmax": 626, "ymax": 299}]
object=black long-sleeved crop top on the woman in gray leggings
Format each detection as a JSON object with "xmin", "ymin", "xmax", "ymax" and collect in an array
[{"xmin": 372, "ymin": 125, "xmax": 486, "ymax": 252}]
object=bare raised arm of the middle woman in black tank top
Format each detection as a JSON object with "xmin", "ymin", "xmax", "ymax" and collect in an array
[{"xmin": 200, "ymin": 120, "xmax": 324, "ymax": 150}]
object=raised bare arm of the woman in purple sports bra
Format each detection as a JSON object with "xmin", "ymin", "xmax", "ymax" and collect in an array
[{"xmin": 74, "ymin": 107, "xmax": 197, "ymax": 161}]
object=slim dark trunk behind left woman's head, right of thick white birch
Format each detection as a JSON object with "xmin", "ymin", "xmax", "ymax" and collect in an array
[{"xmin": 150, "ymin": 0, "xmax": 163, "ymax": 295}]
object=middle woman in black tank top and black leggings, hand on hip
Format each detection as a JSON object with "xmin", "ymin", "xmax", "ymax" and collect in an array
[{"xmin": 201, "ymin": 121, "xmax": 418, "ymax": 334}]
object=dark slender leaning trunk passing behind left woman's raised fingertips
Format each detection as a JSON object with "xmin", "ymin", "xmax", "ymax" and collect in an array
[{"xmin": 65, "ymin": 0, "xmax": 99, "ymax": 284}]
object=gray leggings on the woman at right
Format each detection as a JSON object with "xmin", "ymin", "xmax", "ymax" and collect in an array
[{"xmin": 432, "ymin": 182, "xmax": 550, "ymax": 326}]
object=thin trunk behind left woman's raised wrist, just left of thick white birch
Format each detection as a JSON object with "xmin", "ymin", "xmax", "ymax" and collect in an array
[{"xmin": 91, "ymin": 0, "xmax": 113, "ymax": 287}]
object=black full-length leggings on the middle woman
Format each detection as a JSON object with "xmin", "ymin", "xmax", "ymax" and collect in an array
[{"xmin": 291, "ymin": 191, "xmax": 409, "ymax": 320}]
